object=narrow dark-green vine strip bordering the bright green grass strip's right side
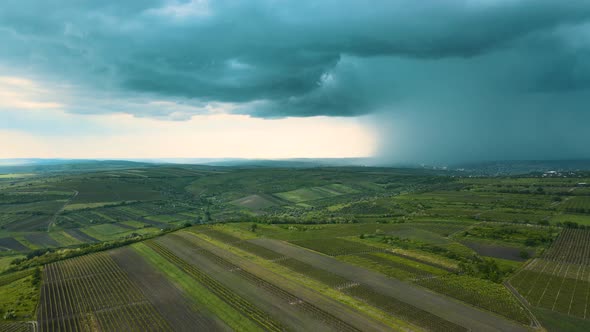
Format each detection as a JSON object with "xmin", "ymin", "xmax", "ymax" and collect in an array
[{"xmin": 146, "ymin": 241, "xmax": 283, "ymax": 331}]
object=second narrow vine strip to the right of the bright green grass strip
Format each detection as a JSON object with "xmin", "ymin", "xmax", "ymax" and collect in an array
[{"xmin": 169, "ymin": 236, "xmax": 358, "ymax": 331}]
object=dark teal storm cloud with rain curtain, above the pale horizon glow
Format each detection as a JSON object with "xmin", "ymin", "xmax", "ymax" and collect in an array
[{"xmin": 0, "ymin": 0, "xmax": 590, "ymax": 160}]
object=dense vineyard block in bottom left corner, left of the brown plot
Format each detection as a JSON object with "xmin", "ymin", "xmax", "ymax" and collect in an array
[{"xmin": 37, "ymin": 253, "xmax": 170, "ymax": 331}]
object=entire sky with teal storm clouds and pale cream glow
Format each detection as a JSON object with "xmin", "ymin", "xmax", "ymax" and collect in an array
[{"xmin": 0, "ymin": 0, "xmax": 590, "ymax": 163}]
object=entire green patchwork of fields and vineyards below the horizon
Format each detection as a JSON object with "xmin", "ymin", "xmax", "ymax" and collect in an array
[{"xmin": 0, "ymin": 165, "xmax": 590, "ymax": 331}]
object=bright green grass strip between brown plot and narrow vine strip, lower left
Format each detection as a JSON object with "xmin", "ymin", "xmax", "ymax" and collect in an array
[{"xmin": 132, "ymin": 243, "xmax": 261, "ymax": 331}]
